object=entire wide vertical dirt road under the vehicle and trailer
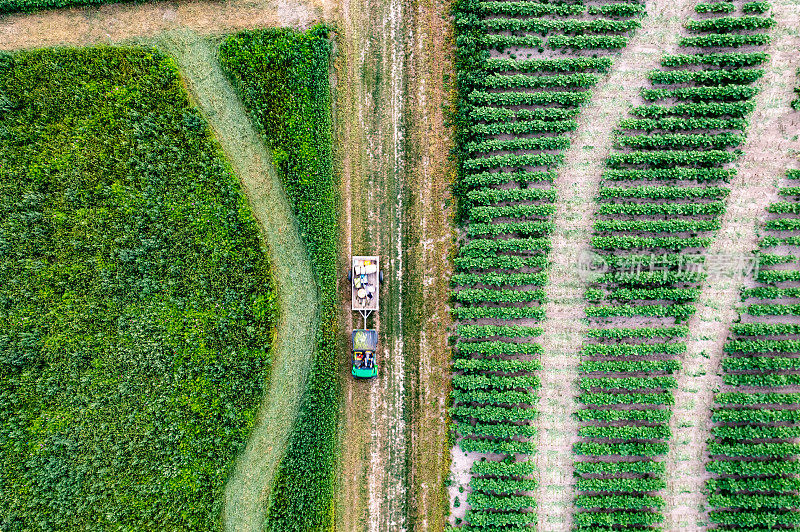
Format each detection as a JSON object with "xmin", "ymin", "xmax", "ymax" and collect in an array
[{"xmin": 336, "ymin": 0, "xmax": 452, "ymax": 532}]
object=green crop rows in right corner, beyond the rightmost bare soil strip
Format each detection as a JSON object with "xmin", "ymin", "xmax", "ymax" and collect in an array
[{"xmin": 707, "ymin": 170, "xmax": 800, "ymax": 530}]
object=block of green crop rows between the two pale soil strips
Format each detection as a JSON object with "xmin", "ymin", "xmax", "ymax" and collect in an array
[{"xmin": 575, "ymin": 2, "xmax": 772, "ymax": 531}]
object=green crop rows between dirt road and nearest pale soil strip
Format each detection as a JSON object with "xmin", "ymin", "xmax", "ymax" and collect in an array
[{"xmin": 450, "ymin": 0, "xmax": 644, "ymax": 531}]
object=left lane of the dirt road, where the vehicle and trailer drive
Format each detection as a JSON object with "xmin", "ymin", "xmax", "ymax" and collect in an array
[{"xmin": 336, "ymin": 0, "xmax": 413, "ymax": 531}]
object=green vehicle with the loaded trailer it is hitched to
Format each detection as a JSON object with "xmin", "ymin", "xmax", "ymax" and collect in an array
[{"xmin": 347, "ymin": 255, "xmax": 383, "ymax": 379}]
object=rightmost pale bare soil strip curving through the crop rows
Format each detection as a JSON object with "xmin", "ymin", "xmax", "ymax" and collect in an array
[{"xmin": 664, "ymin": 4, "xmax": 800, "ymax": 531}]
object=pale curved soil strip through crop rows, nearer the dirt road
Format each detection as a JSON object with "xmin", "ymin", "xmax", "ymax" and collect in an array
[{"xmin": 536, "ymin": 0, "xmax": 680, "ymax": 531}]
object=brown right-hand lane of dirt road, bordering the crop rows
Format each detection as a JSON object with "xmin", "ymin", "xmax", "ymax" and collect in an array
[{"xmin": 406, "ymin": 0, "xmax": 455, "ymax": 530}]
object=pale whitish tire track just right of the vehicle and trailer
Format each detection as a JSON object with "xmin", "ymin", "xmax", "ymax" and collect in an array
[{"xmin": 367, "ymin": 0, "xmax": 408, "ymax": 532}]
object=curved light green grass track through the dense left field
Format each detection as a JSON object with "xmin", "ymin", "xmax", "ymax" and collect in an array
[{"xmin": 158, "ymin": 30, "xmax": 319, "ymax": 532}]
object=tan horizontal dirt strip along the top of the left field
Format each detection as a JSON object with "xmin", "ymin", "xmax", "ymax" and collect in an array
[{"xmin": 0, "ymin": 0, "xmax": 328, "ymax": 50}]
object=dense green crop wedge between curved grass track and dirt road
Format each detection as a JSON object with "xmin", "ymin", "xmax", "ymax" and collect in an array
[{"xmin": 220, "ymin": 26, "xmax": 338, "ymax": 531}]
